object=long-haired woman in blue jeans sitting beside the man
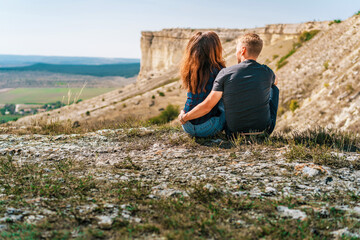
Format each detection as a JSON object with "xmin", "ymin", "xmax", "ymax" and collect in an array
[{"xmin": 181, "ymin": 32, "xmax": 225, "ymax": 137}]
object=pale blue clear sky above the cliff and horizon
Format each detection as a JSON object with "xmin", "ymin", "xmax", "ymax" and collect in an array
[{"xmin": 0, "ymin": 0, "xmax": 360, "ymax": 58}]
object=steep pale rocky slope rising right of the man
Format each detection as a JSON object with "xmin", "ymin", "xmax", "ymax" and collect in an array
[{"xmin": 276, "ymin": 15, "xmax": 360, "ymax": 133}]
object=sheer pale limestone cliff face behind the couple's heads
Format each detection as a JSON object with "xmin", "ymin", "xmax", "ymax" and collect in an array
[{"xmin": 138, "ymin": 22, "xmax": 328, "ymax": 81}]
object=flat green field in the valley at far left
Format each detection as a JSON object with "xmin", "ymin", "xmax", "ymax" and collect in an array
[{"xmin": 0, "ymin": 88, "xmax": 115, "ymax": 104}]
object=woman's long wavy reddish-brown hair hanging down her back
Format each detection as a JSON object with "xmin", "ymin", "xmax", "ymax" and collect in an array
[{"xmin": 181, "ymin": 31, "xmax": 225, "ymax": 94}]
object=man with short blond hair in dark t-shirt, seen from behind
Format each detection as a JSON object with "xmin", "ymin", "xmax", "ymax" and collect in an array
[{"xmin": 179, "ymin": 33, "xmax": 279, "ymax": 135}]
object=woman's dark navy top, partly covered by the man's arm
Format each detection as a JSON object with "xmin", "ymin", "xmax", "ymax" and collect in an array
[{"xmin": 184, "ymin": 66, "xmax": 221, "ymax": 125}]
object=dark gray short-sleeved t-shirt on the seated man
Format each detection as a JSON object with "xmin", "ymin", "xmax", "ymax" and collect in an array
[{"xmin": 212, "ymin": 60, "xmax": 275, "ymax": 133}]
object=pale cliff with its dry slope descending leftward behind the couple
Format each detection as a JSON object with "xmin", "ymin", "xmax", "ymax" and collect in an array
[{"xmin": 17, "ymin": 22, "xmax": 329, "ymax": 125}]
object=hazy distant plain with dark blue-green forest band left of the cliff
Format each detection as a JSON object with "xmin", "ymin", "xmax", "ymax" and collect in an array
[{"xmin": 0, "ymin": 55, "xmax": 140, "ymax": 89}]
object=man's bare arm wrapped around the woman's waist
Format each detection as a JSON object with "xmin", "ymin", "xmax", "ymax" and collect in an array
[{"xmin": 178, "ymin": 91, "xmax": 223, "ymax": 124}]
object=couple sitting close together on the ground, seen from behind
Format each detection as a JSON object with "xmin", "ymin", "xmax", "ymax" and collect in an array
[{"xmin": 179, "ymin": 32, "xmax": 279, "ymax": 137}]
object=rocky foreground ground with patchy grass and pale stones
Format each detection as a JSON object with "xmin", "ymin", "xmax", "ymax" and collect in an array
[{"xmin": 0, "ymin": 126, "xmax": 360, "ymax": 239}]
